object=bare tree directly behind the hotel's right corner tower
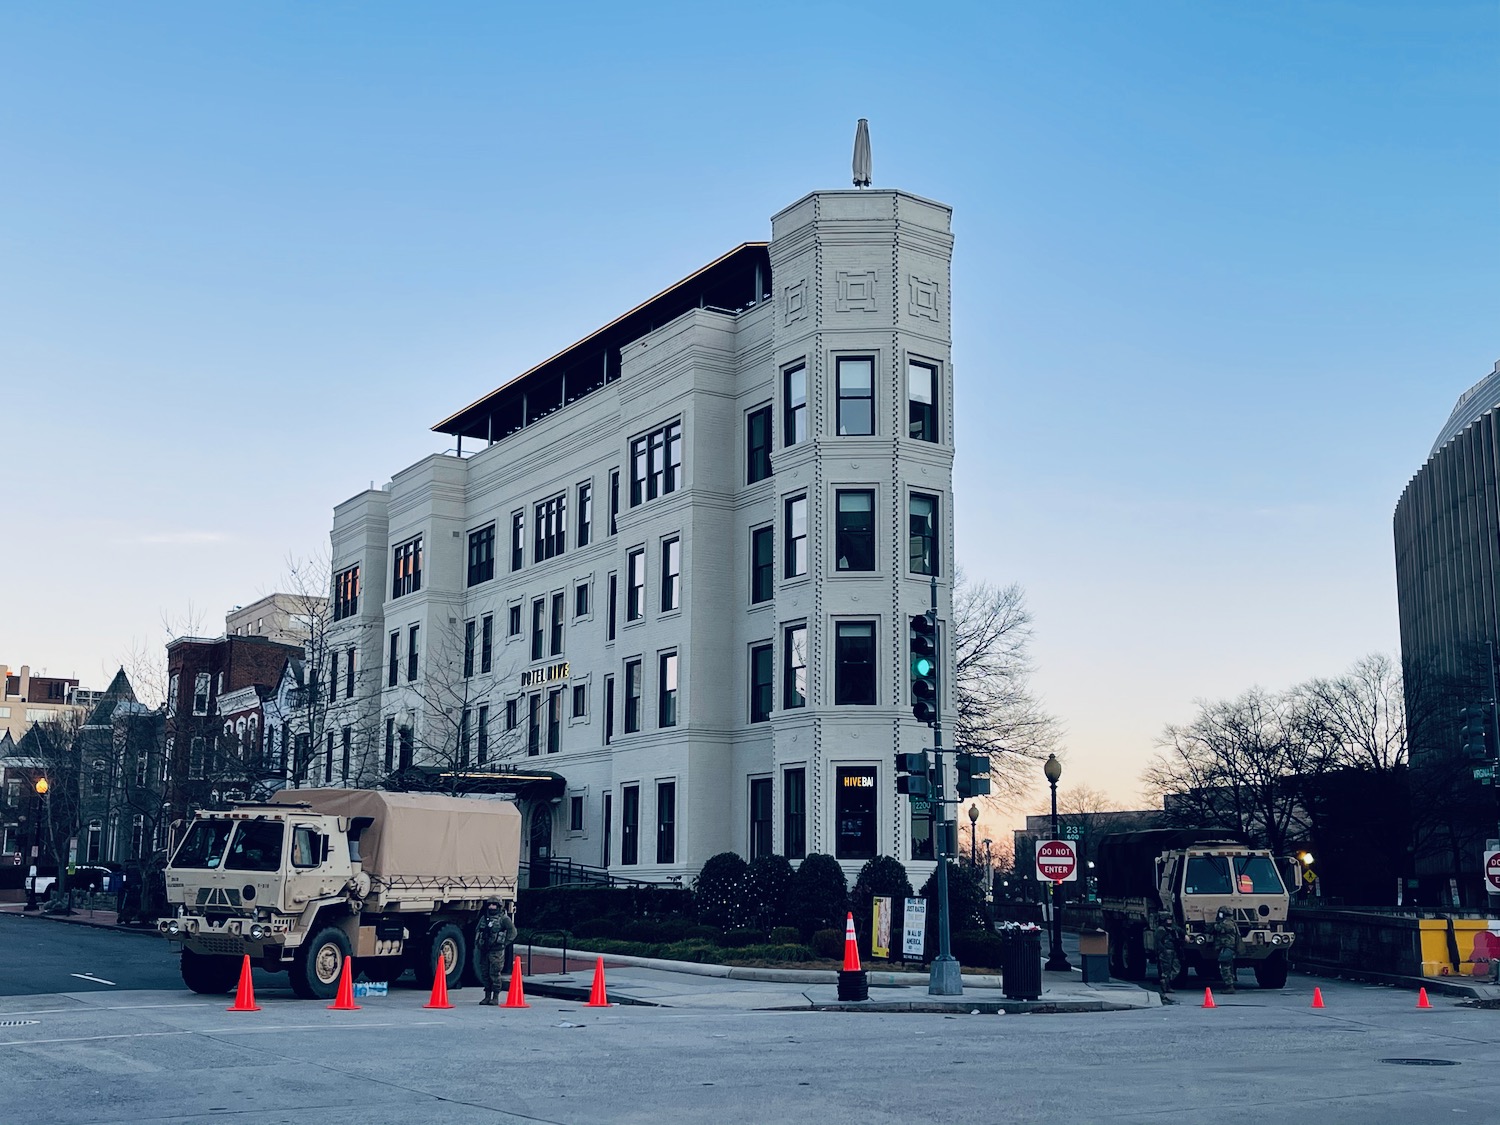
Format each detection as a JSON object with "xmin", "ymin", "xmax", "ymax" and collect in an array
[{"xmin": 953, "ymin": 572, "xmax": 1059, "ymax": 798}]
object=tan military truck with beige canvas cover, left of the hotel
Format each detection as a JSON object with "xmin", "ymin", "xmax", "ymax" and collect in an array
[{"xmin": 158, "ymin": 789, "xmax": 521, "ymax": 999}]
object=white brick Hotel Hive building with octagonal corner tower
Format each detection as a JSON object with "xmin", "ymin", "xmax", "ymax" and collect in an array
[{"xmin": 330, "ymin": 191, "xmax": 954, "ymax": 879}]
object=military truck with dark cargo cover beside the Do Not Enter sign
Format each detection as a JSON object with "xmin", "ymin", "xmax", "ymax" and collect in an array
[{"xmin": 1097, "ymin": 828, "xmax": 1296, "ymax": 989}]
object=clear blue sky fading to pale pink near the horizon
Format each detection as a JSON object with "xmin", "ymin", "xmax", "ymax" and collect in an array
[{"xmin": 0, "ymin": 0, "xmax": 1500, "ymax": 801}]
